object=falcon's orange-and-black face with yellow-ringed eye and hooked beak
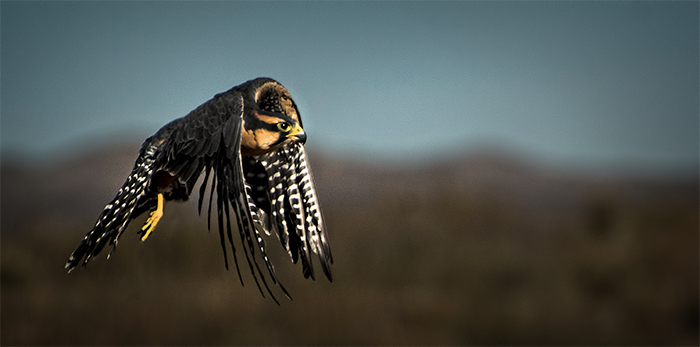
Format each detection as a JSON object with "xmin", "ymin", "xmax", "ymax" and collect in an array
[{"xmin": 241, "ymin": 110, "xmax": 306, "ymax": 156}]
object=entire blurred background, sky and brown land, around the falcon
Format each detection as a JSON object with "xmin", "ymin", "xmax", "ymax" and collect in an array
[{"xmin": 0, "ymin": 2, "xmax": 700, "ymax": 345}]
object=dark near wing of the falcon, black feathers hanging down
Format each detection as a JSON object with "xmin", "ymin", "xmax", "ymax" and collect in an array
[{"xmin": 163, "ymin": 88, "xmax": 289, "ymax": 301}]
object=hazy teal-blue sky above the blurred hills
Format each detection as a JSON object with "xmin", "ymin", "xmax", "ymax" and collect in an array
[{"xmin": 0, "ymin": 1, "xmax": 700, "ymax": 169}]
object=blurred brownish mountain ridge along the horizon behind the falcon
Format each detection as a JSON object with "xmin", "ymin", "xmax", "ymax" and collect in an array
[{"xmin": 0, "ymin": 143, "xmax": 698, "ymax": 237}]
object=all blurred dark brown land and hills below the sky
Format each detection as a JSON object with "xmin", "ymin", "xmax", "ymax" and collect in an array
[{"xmin": 0, "ymin": 144, "xmax": 700, "ymax": 345}]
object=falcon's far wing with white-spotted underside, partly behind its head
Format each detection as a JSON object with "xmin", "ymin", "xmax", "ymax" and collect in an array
[{"xmin": 244, "ymin": 78, "xmax": 333, "ymax": 281}]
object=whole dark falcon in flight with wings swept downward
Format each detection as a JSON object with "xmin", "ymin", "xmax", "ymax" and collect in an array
[{"xmin": 65, "ymin": 78, "xmax": 333, "ymax": 302}]
